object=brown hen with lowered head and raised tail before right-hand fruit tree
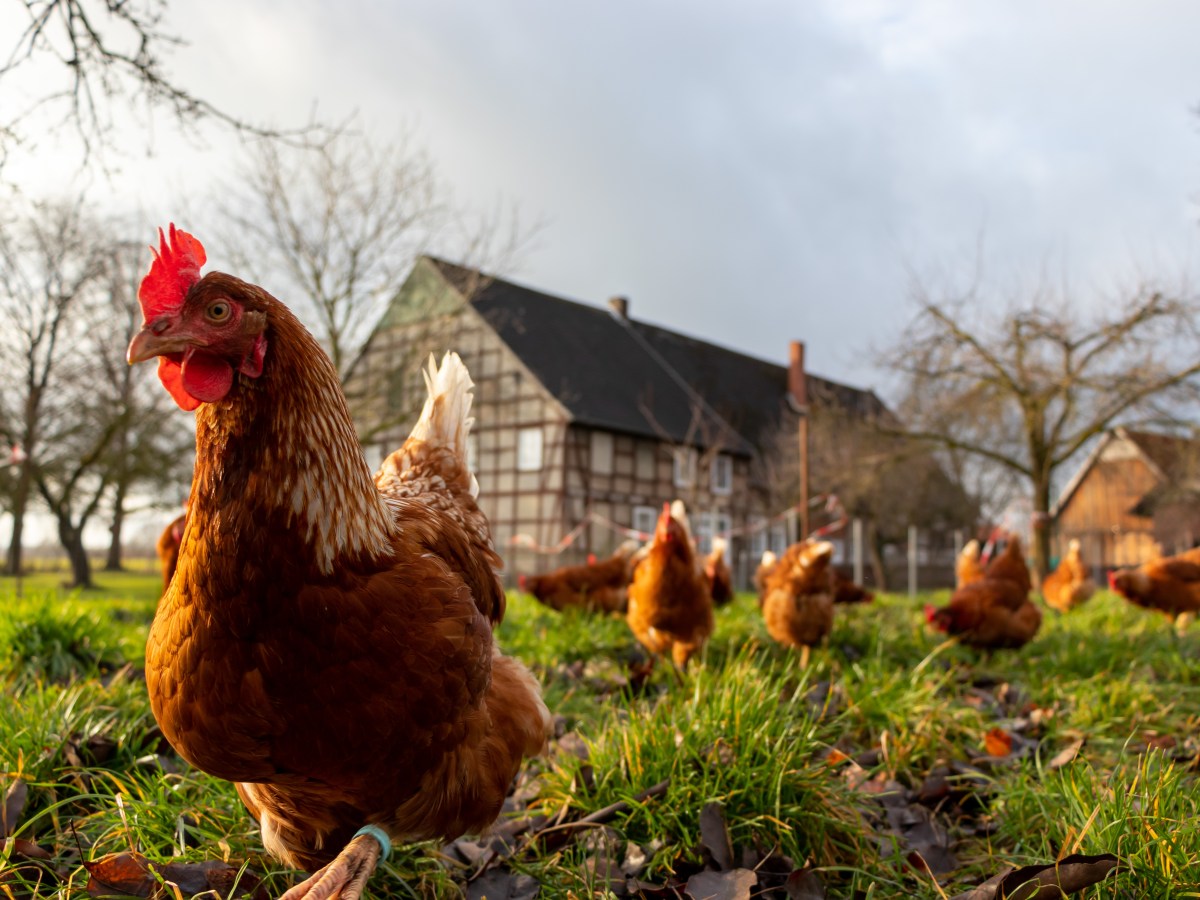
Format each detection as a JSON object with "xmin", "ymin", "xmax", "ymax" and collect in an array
[{"xmin": 925, "ymin": 536, "xmax": 1042, "ymax": 650}]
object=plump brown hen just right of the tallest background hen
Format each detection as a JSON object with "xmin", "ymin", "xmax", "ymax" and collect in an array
[{"xmin": 762, "ymin": 540, "xmax": 834, "ymax": 666}]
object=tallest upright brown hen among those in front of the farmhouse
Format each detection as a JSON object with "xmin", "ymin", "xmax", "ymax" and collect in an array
[{"xmin": 625, "ymin": 504, "xmax": 713, "ymax": 668}]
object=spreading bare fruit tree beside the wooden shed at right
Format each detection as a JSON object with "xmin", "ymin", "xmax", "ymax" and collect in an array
[{"xmin": 883, "ymin": 270, "xmax": 1200, "ymax": 574}]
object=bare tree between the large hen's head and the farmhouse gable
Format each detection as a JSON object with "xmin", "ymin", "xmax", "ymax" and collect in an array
[{"xmin": 215, "ymin": 130, "xmax": 532, "ymax": 440}]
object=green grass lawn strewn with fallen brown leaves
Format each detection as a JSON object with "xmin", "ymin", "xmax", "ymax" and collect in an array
[{"xmin": 0, "ymin": 572, "xmax": 1200, "ymax": 898}]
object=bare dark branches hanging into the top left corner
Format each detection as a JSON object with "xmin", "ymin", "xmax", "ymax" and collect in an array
[{"xmin": 0, "ymin": 0, "xmax": 306, "ymax": 170}]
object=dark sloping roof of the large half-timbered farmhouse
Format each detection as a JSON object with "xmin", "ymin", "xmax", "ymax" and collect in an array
[{"xmin": 431, "ymin": 258, "xmax": 884, "ymax": 454}]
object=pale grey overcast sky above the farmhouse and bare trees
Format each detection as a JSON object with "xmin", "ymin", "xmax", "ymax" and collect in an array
[{"xmin": 0, "ymin": 0, "xmax": 1200, "ymax": 388}]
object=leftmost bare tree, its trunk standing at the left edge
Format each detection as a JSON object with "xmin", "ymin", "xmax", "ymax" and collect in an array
[{"xmin": 0, "ymin": 203, "xmax": 102, "ymax": 575}]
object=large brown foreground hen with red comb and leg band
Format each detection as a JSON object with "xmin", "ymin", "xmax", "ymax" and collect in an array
[{"xmin": 128, "ymin": 227, "xmax": 548, "ymax": 900}]
